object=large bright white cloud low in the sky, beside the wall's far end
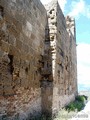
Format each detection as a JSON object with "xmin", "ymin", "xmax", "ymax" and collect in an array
[{"xmin": 77, "ymin": 44, "xmax": 90, "ymax": 88}]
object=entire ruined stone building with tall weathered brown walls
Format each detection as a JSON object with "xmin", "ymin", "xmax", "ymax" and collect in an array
[{"xmin": 0, "ymin": 0, "xmax": 77, "ymax": 120}]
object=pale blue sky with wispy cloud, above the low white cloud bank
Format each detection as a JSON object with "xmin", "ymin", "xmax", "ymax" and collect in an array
[{"xmin": 64, "ymin": 0, "xmax": 90, "ymax": 44}]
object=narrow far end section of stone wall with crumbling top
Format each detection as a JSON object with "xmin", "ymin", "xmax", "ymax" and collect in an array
[{"xmin": 66, "ymin": 16, "xmax": 78, "ymax": 95}]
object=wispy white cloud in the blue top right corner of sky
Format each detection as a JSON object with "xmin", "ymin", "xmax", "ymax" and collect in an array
[{"xmin": 69, "ymin": 0, "xmax": 90, "ymax": 18}]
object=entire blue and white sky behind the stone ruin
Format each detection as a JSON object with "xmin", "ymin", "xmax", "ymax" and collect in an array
[{"xmin": 41, "ymin": 0, "xmax": 90, "ymax": 91}]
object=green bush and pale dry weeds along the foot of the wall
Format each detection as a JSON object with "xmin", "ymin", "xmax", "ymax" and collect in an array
[{"xmin": 35, "ymin": 95, "xmax": 87, "ymax": 120}]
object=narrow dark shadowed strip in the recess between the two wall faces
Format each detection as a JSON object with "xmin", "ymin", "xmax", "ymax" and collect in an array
[{"xmin": 41, "ymin": 22, "xmax": 53, "ymax": 119}]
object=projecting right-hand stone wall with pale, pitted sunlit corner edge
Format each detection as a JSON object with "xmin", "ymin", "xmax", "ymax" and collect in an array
[{"xmin": 46, "ymin": 1, "xmax": 77, "ymax": 114}]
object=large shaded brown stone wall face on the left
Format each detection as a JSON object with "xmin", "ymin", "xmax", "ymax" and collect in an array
[{"xmin": 0, "ymin": 0, "xmax": 47, "ymax": 120}]
